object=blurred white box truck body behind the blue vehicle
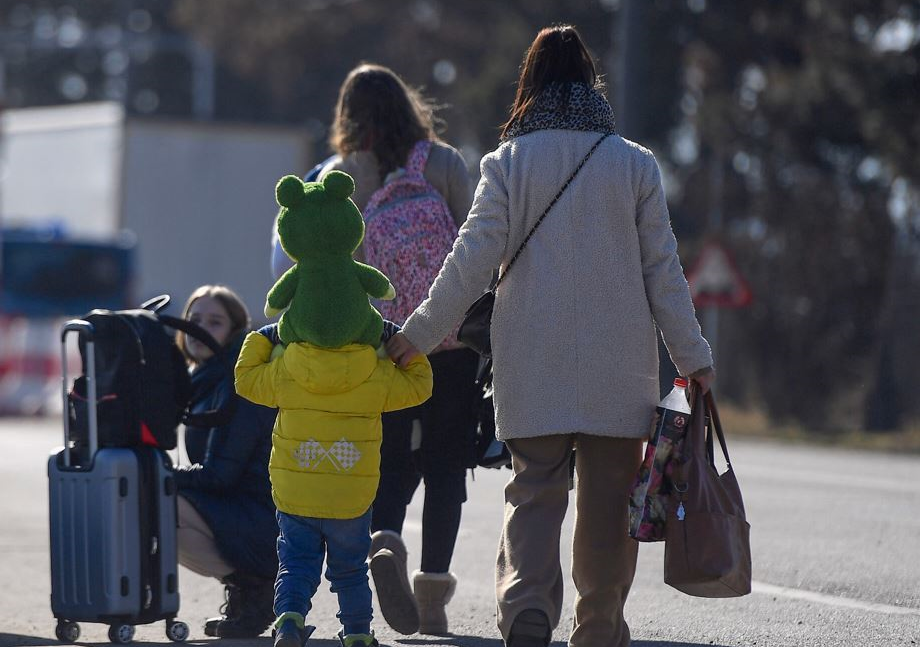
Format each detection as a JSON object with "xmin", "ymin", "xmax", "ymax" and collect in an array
[{"xmin": 0, "ymin": 102, "xmax": 312, "ymax": 321}]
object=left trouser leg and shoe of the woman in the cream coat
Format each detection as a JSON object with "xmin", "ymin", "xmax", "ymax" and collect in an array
[{"xmin": 495, "ymin": 435, "xmax": 574, "ymax": 647}]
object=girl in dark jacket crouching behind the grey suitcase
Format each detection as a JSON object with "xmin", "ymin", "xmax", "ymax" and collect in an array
[{"xmin": 176, "ymin": 285, "xmax": 278, "ymax": 638}]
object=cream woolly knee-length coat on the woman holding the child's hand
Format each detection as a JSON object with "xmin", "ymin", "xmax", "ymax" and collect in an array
[{"xmin": 403, "ymin": 130, "xmax": 712, "ymax": 440}]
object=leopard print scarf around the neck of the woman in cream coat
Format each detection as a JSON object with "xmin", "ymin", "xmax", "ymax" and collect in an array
[{"xmin": 502, "ymin": 83, "xmax": 616, "ymax": 141}]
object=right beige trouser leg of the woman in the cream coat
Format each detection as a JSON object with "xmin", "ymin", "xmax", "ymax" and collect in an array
[{"xmin": 569, "ymin": 434, "xmax": 642, "ymax": 647}]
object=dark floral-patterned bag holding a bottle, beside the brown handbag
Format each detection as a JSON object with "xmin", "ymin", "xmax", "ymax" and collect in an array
[{"xmin": 629, "ymin": 394, "xmax": 688, "ymax": 541}]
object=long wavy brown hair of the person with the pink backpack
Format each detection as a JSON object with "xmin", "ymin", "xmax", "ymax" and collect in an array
[{"xmin": 329, "ymin": 63, "xmax": 438, "ymax": 180}]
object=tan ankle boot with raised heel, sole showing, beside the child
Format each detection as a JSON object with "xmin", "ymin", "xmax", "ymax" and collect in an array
[{"xmin": 370, "ymin": 530, "xmax": 418, "ymax": 636}]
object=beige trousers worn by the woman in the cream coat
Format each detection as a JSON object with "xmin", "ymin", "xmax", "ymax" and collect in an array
[{"xmin": 495, "ymin": 434, "xmax": 642, "ymax": 647}]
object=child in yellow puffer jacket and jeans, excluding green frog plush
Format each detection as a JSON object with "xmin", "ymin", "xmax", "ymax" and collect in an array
[{"xmin": 236, "ymin": 327, "xmax": 432, "ymax": 647}]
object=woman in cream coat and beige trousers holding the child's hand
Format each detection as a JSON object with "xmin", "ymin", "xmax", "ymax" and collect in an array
[{"xmin": 388, "ymin": 26, "xmax": 714, "ymax": 647}]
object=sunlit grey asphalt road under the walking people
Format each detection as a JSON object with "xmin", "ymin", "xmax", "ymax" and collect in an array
[{"xmin": 0, "ymin": 419, "xmax": 920, "ymax": 647}]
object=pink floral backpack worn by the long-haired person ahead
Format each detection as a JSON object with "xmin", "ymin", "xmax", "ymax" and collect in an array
[{"xmin": 364, "ymin": 140, "xmax": 460, "ymax": 350}]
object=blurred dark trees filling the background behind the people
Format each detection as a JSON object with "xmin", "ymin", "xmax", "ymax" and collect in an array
[{"xmin": 0, "ymin": 0, "xmax": 920, "ymax": 431}]
